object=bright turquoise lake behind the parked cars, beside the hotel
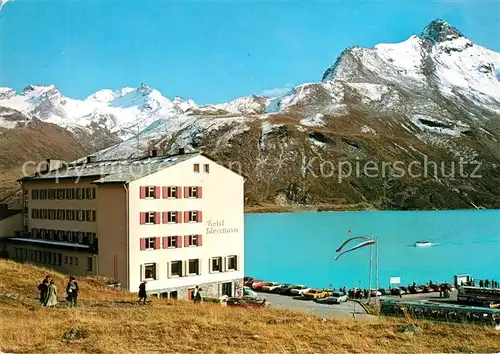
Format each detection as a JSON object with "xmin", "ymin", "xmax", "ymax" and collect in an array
[{"xmin": 245, "ymin": 210, "xmax": 500, "ymax": 288}]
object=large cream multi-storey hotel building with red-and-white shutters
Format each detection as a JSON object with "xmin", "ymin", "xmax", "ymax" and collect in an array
[{"xmin": 0, "ymin": 151, "xmax": 244, "ymax": 299}]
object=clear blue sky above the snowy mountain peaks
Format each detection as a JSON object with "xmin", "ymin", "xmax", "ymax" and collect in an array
[{"xmin": 0, "ymin": 0, "xmax": 500, "ymax": 104}]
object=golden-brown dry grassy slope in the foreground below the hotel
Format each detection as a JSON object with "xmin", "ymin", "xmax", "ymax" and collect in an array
[{"xmin": 0, "ymin": 260, "xmax": 500, "ymax": 353}]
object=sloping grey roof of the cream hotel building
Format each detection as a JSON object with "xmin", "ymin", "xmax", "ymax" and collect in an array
[{"xmin": 19, "ymin": 152, "xmax": 200, "ymax": 183}]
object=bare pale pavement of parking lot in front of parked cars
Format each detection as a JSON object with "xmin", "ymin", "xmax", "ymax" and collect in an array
[{"xmin": 259, "ymin": 293, "xmax": 373, "ymax": 319}]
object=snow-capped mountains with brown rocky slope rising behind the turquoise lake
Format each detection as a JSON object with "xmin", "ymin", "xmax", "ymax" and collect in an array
[{"xmin": 0, "ymin": 20, "xmax": 500, "ymax": 209}]
